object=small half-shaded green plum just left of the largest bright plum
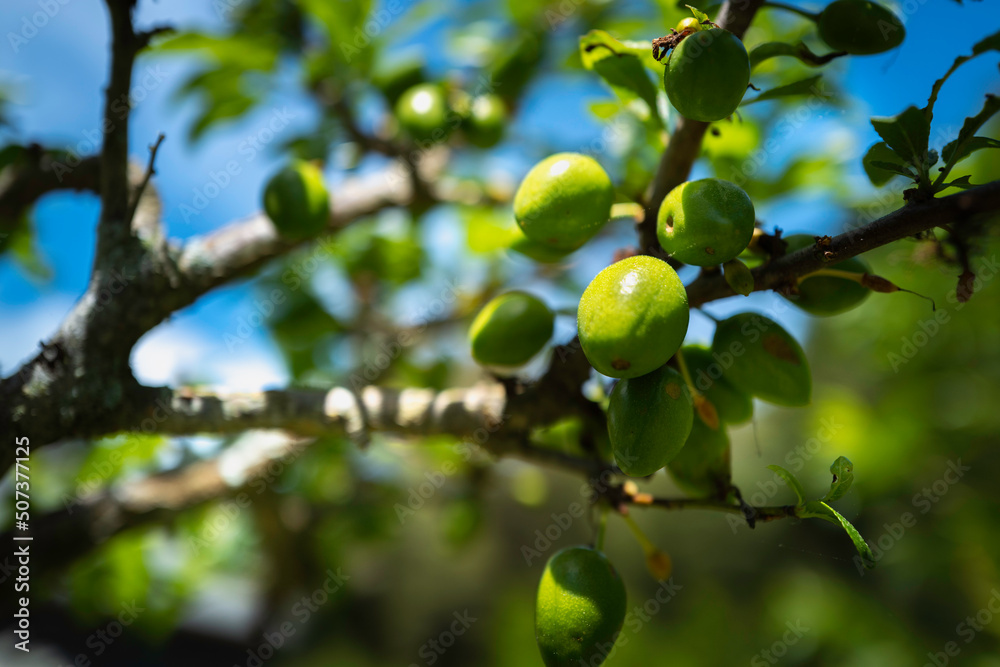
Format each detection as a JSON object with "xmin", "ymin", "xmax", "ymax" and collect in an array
[{"xmin": 469, "ymin": 292, "xmax": 555, "ymax": 366}]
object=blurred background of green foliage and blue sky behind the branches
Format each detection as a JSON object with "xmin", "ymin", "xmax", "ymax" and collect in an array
[{"xmin": 0, "ymin": 0, "xmax": 1000, "ymax": 667}]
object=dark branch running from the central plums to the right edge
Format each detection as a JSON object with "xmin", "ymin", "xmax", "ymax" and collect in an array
[{"xmin": 687, "ymin": 181, "xmax": 1000, "ymax": 307}]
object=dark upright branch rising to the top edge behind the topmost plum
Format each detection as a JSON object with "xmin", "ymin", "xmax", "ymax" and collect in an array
[{"xmin": 638, "ymin": 0, "xmax": 764, "ymax": 254}]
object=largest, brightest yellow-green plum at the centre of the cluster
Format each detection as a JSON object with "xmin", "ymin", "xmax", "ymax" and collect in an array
[{"xmin": 577, "ymin": 255, "xmax": 689, "ymax": 378}]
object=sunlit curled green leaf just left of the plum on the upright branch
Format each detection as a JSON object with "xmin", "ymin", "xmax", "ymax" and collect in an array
[{"xmin": 580, "ymin": 30, "xmax": 662, "ymax": 124}]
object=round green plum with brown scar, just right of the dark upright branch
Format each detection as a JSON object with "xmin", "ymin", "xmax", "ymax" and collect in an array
[{"xmin": 656, "ymin": 183, "xmax": 756, "ymax": 266}]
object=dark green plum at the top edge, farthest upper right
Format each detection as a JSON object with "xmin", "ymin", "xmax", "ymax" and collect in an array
[{"xmin": 816, "ymin": 0, "xmax": 906, "ymax": 56}]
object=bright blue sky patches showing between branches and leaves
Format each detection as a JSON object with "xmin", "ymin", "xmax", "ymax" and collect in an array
[{"xmin": 0, "ymin": 0, "xmax": 1000, "ymax": 389}]
